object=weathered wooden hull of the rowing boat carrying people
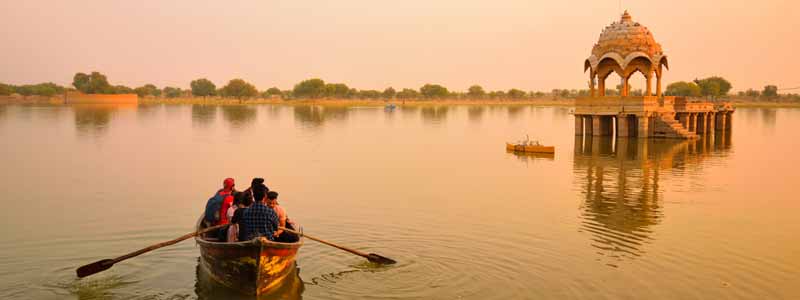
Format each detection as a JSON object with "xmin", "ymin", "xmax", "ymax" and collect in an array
[{"xmin": 195, "ymin": 218, "xmax": 303, "ymax": 295}]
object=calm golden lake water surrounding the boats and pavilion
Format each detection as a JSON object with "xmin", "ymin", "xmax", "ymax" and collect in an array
[{"xmin": 0, "ymin": 105, "xmax": 800, "ymax": 299}]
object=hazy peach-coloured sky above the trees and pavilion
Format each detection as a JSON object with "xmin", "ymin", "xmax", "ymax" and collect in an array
[{"xmin": 0, "ymin": 0, "xmax": 800, "ymax": 91}]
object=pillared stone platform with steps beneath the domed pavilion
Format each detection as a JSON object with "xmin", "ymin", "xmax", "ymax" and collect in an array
[{"xmin": 574, "ymin": 96, "xmax": 734, "ymax": 139}]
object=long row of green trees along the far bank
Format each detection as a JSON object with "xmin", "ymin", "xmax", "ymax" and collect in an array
[{"xmin": 0, "ymin": 72, "xmax": 800, "ymax": 101}]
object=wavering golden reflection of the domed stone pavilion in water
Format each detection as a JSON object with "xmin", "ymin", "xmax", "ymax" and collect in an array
[{"xmin": 573, "ymin": 134, "xmax": 730, "ymax": 266}]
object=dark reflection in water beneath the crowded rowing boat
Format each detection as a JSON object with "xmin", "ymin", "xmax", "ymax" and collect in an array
[{"xmin": 194, "ymin": 258, "xmax": 305, "ymax": 300}]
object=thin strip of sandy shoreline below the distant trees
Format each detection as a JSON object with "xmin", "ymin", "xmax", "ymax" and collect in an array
[{"xmin": 0, "ymin": 96, "xmax": 800, "ymax": 108}]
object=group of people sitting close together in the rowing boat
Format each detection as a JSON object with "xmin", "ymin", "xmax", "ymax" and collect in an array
[{"xmin": 203, "ymin": 178, "xmax": 299, "ymax": 243}]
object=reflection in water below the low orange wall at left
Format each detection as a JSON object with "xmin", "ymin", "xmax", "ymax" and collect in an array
[{"xmin": 72, "ymin": 103, "xmax": 137, "ymax": 136}]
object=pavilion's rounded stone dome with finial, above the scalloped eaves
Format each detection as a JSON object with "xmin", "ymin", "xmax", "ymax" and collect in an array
[{"xmin": 592, "ymin": 11, "xmax": 663, "ymax": 58}]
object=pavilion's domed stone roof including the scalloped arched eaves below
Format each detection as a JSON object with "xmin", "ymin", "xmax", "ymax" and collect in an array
[{"xmin": 584, "ymin": 11, "xmax": 669, "ymax": 73}]
